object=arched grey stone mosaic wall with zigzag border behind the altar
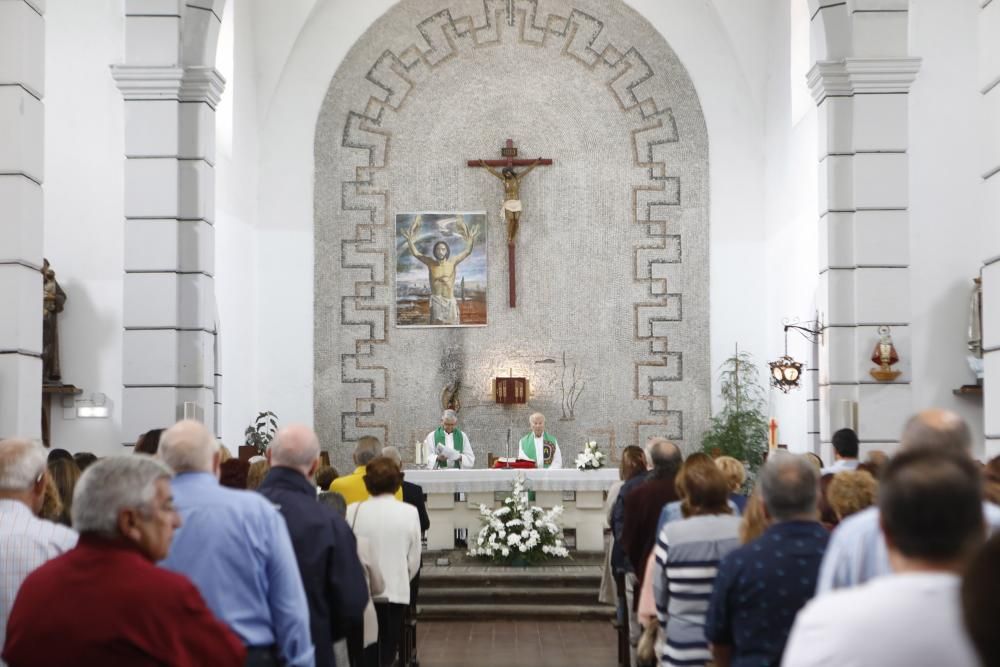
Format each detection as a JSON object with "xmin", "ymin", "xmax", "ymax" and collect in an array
[{"xmin": 314, "ymin": 0, "xmax": 711, "ymax": 466}]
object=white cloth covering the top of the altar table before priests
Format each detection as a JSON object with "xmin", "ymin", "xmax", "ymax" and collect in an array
[{"xmin": 405, "ymin": 467, "xmax": 618, "ymax": 493}]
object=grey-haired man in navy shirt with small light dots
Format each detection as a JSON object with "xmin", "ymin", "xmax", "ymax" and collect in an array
[{"xmin": 705, "ymin": 452, "xmax": 829, "ymax": 666}]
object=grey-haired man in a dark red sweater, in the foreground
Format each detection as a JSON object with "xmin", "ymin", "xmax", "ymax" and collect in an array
[{"xmin": 3, "ymin": 454, "xmax": 246, "ymax": 667}]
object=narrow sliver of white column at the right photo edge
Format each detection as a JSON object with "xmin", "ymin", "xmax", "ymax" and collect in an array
[{"xmin": 979, "ymin": 0, "xmax": 1000, "ymax": 458}]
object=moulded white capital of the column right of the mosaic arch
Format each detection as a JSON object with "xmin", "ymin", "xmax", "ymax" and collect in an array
[{"xmin": 807, "ymin": 58, "xmax": 920, "ymax": 104}]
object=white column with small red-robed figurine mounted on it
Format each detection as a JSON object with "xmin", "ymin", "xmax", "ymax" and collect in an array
[{"xmin": 809, "ymin": 0, "xmax": 920, "ymax": 458}]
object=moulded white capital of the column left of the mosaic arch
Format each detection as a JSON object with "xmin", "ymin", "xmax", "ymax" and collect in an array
[{"xmin": 111, "ymin": 65, "xmax": 226, "ymax": 109}]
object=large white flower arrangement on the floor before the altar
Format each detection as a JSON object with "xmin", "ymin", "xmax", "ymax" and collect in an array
[{"xmin": 469, "ymin": 475, "xmax": 569, "ymax": 563}]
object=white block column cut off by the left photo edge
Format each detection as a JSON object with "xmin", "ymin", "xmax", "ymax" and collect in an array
[{"xmin": 0, "ymin": 0, "xmax": 45, "ymax": 438}]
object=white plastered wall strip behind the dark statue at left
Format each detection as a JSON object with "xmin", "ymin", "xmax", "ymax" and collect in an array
[{"xmin": 39, "ymin": 0, "xmax": 124, "ymax": 455}]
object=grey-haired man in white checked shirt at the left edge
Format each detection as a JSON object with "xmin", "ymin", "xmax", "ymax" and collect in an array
[{"xmin": 0, "ymin": 439, "xmax": 76, "ymax": 646}]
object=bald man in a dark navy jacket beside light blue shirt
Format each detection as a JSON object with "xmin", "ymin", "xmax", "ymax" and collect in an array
[{"xmin": 257, "ymin": 424, "xmax": 368, "ymax": 667}]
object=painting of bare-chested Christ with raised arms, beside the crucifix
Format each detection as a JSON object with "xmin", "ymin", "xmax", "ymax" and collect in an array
[{"xmin": 396, "ymin": 211, "xmax": 487, "ymax": 327}]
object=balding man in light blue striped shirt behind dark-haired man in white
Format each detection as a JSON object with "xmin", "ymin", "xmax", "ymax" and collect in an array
[{"xmin": 816, "ymin": 408, "xmax": 1000, "ymax": 595}]
